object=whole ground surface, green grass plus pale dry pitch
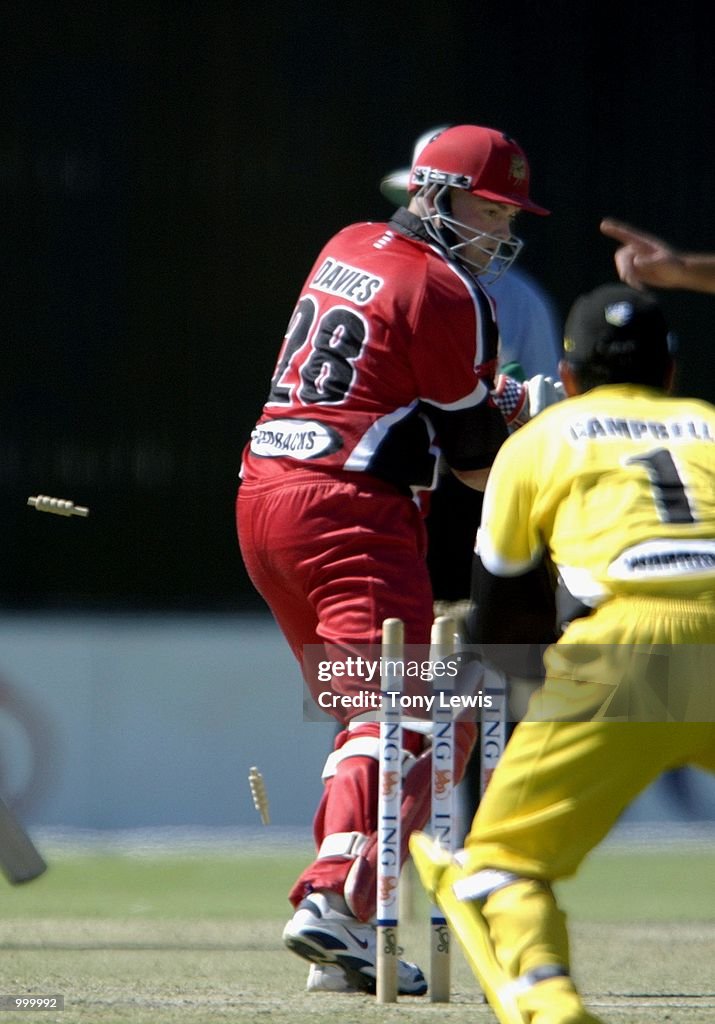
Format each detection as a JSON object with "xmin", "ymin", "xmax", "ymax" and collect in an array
[{"xmin": 0, "ymin": 834, "xmax": 715, "ymax": 1024}]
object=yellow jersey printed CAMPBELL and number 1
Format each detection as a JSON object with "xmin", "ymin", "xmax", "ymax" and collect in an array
[{"xmin": 477, "ymin": 384, "xmax": 715, "ymax": 607}]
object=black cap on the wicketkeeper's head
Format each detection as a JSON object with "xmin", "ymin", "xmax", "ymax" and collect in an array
[{"xmin": 563, "ymin": 284, "xmax": 671, "ymax": 368}]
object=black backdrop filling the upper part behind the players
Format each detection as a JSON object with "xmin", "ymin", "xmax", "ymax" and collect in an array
[{"xmin": 0, "ymin": 0, "xmax": 715, "ymax": 609}]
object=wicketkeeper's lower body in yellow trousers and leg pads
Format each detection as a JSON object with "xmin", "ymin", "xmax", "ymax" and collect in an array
[{"xmin": 440, "ymin": 597, "xmax": 715, "ymax": 1024}]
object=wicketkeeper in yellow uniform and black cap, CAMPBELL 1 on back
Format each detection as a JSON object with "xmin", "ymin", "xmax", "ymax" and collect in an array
[{"xmin": 411, "ymin": 284, "xmax": 715, "ymax": 1024}]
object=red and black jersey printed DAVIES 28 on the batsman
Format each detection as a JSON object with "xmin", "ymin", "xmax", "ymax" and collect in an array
[{"xmin": 242, "ymin": 210, "xmax": 507, "ymax": 490}]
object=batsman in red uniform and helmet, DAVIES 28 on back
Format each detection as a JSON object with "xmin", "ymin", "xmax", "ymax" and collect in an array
[{"xmin": 237, "ymin": 125, "xmax": 548, "ymax": 994}]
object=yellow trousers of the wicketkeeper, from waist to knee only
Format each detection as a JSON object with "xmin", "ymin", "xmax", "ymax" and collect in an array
[{"xmin": 465, "ymin": 595, "xmax": 715, "ymax": 882}]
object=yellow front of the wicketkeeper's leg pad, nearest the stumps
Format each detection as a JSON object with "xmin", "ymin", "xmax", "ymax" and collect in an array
[{"xmin": 410, "ymin": 833, "xmax": 528, "ymax": 1024}]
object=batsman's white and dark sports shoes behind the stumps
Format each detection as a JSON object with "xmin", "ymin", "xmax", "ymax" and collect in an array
[{"xmin": 283, "ymin": 892, "xmax": 427, "ymax": 995}]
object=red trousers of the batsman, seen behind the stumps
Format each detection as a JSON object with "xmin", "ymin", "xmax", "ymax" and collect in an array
[{"xmin": 237, "ymin": 468, "xmax": 473, "ymax": 917}]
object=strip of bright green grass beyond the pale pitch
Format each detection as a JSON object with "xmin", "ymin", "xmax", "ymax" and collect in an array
[{"xmin": 0, "ymin": 850, "xmax": 715, "ymax": 923}]
